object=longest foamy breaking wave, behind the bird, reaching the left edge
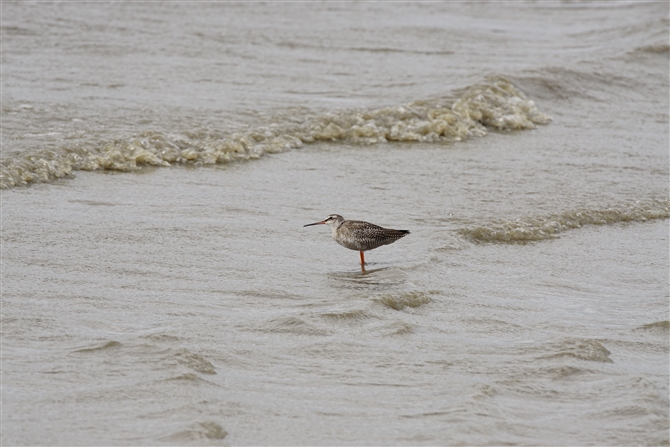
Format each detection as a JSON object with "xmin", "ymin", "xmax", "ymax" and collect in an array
[{"xmin": 0, "ymin": 76, "xmax": 551, "ymax": 189}]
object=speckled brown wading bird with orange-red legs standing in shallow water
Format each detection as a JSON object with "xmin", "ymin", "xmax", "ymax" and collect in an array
[{"xmin": 304, "ymin": 214, "xmax": 409, "ymax": 267}]
